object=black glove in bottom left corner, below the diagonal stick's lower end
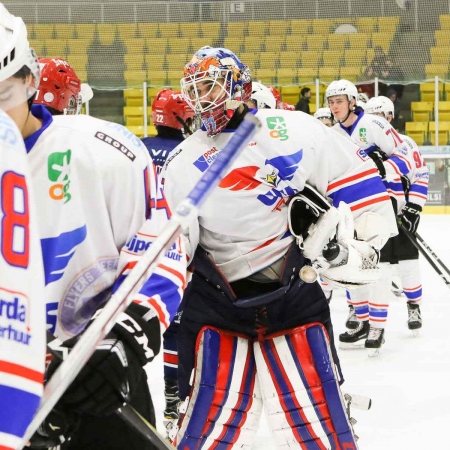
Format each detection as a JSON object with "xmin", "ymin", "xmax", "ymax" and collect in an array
[{"xmin": 26, "ymin": 404, "xmax": 80, "ymax": 449}]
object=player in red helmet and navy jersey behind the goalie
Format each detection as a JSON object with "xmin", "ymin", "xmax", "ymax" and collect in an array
[{"xmin": 142, "ymin": 89, "xmax": 194, "ymax": 173}]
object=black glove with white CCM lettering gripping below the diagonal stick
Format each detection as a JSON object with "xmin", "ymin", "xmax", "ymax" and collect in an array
[{"xmin": 47, "ymin": 303, "xmax": 161, "ymax": 416}]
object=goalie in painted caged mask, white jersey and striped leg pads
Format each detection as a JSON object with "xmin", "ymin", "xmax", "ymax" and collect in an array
[{"xmin": 162, "ymin": 48, "xmax": 396, "ymax": 449}]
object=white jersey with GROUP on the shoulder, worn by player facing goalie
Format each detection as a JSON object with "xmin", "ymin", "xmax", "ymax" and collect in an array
[{"xmin": 25, "ymin": 105, "xmax": 185, "ymax": 339}]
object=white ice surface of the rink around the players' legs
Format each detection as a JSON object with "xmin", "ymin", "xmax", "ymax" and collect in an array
[{"xmin": 149, "ymin": 215, "xmax": 450, "ymax": 450}]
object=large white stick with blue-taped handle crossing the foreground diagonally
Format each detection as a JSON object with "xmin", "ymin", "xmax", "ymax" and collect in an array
[{"xmin": 21, "ymin": 114, "xmax": 261, "ymax": 448}]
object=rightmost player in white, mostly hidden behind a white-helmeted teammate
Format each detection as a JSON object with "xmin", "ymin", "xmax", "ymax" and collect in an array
[{"xmin": 365, "ymin": 96, "xmax": 429, "ymax": 332}]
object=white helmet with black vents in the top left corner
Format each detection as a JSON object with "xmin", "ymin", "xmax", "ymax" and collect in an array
[{"xmin": 0, "ymin": 3, "xmax": 40, "ymax": 109}]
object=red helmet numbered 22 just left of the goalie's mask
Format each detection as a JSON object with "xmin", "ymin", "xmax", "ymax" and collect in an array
[{"xmin": 152, "ymin": 89, "xmax": 194, "ymax": 130}]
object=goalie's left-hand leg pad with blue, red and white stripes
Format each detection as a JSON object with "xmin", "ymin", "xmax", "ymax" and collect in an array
[{"xmin": 176, "ymin": 327, "xmax": 262, "ymax": 450}]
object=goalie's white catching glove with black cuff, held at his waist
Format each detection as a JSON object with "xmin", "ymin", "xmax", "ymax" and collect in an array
[{"xmin": 289, "ymin": 186, "xmax": 390, "ymax": 289}]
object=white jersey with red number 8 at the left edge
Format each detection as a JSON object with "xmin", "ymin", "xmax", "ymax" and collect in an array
[{"xmin": 0, "ymin": 110, "xmax": 46, "ymax": 450}]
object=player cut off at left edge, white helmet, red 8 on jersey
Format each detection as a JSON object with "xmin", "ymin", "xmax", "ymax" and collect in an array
[{"xmin": 0, "ymin": 4, "xmax": 46, "ymax": 450}]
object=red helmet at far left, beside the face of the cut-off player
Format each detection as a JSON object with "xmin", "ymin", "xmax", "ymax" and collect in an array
[{"xmin": 34, "ymin": 58, "xmax": 81, "ymax": 114}]
